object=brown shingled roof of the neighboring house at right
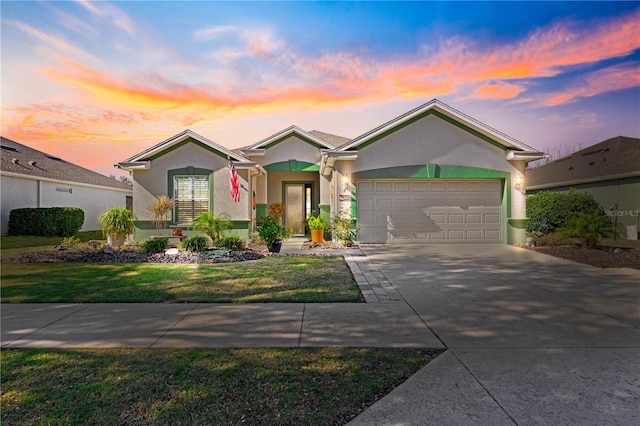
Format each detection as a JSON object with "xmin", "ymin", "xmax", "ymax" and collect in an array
[{"xmin": 526, "ymin": 136, "xmax": 640, "ymax": 189}]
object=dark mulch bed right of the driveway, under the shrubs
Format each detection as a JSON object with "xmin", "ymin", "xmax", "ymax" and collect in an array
[{"xmin": 521, "ymin": 245, "xmax": 640, "ymax": 269}]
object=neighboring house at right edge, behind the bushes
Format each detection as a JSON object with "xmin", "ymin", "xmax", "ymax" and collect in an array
[{"xmin": 526, "ymin": 136, "xmax": 640, "ymax": 235}]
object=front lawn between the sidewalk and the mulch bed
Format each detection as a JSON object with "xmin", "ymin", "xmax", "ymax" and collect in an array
[{"xmin": 0, "ymin": 256, "xmax": 362, "ymax": 303}]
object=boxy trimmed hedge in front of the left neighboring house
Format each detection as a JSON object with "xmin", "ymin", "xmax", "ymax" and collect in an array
[{"xmin": 8, "ymin": 207, "xmax": 84, "ymax": 237}]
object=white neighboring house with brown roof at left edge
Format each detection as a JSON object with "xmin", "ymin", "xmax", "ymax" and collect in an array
[{"xmin": 0, "ymin": 138, "xmax": 133, "ymax": 235}]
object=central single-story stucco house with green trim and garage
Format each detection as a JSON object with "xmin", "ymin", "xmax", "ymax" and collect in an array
[{"xmin": 116, "ymin": 100, "xmax": 543, "ymax": 243}]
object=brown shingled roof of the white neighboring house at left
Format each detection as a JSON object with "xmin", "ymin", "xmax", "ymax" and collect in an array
[{"xmin": 0, "ymin": 137, "xmax": 131, "ymax": 190}]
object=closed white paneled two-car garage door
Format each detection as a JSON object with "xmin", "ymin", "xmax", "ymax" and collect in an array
[{"xmin": 356, "ymin": 179, "xmax": 502, "ymax": 243}]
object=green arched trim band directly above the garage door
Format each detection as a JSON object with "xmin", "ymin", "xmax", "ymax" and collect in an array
[{"xmin": 352, "ymin": 164, "xmax": 510, "ymax": 180}]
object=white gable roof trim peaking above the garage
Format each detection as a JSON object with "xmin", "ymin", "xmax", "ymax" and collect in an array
[{"xmin": 335, "ymin": 99, "xmax": 537, "ymax": 153}]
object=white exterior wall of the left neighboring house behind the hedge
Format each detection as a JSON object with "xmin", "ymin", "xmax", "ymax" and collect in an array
[{"xmin": 1, "ymin": 172, "xmax": 132, "ymax": 234}]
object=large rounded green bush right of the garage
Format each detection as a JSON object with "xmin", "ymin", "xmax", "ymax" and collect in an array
[{"xmin": 526, "ymin": 189, "xmax": 600, "ymax": 236}]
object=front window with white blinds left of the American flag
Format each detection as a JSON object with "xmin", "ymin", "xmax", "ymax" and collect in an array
[{"xmin": 173, "ymin": 175, "xmax": 209, "ymax": 223}]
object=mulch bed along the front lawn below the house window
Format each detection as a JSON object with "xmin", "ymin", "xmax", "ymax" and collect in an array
[{"xmin": 2, "ymin": 248, "xmax": 264, "ymax": 263}]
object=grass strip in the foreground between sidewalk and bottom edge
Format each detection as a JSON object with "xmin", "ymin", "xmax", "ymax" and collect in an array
[{"xmin": 1, "ymin": 348, "xmax": 437, "ymax": 425}]
